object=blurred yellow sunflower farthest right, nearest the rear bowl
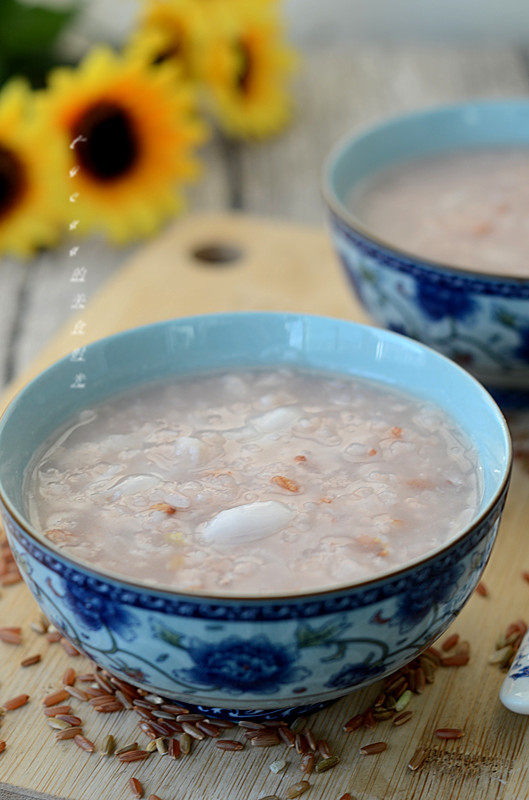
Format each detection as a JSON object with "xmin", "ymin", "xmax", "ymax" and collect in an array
[{"xmin": 197, "ymin": 0, "xmax": 296, "ymax": 137}]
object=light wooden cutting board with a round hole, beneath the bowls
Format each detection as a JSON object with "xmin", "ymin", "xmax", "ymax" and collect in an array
[{"xmin": 0, "ymin": 215, "xmax": 529, "ymax": 800}]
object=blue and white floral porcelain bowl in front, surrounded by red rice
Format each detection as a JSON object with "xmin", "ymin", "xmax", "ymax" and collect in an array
[{"xmin": 0, "ymin": 313, "xmax": 511, "ymax": 717}]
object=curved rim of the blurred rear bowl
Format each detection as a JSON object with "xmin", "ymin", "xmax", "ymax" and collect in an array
[{"xmin": 320, "ymin": 95, "xmax": 529, "ymax": 286}]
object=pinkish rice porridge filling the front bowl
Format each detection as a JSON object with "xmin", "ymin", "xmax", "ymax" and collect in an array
[{"xmin": 27, "ymin": 368, "xmax": 481, "ymax": 596}]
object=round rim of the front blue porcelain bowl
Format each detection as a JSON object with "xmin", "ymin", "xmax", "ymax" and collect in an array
[{"xmin": 0, "ymin": 311, "xmax": 513, "ymax": 604}]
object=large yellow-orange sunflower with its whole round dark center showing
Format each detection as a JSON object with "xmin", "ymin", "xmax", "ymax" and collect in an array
[{"xmin": 42, "ymin": 47, "xmax": 204, "ymax": 242}]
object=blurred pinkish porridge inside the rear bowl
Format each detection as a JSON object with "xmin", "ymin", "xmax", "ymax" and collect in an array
[{"xmin": 350, "ymin": 147, "xmax": 529, "ymax": 278}]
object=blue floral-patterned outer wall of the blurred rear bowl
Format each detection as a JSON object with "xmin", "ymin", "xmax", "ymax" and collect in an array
[{"xmin": 332, "ymin": 215, "xmax": 529, "ymax": 405}]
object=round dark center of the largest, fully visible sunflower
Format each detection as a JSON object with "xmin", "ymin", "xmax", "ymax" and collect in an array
[{"xmin": 72, "ymin": 102, "xmax": 139, "ymax": 181}]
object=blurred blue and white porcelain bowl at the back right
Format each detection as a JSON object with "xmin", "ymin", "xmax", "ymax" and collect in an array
[{"xmin": 323, "ymin": 99, "xmax": 529, "ymax": 407}]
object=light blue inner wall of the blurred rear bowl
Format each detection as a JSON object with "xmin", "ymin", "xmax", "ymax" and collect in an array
[{"xmin": 324, "ymin": 99, "xmax": 529, "ymax": 219}]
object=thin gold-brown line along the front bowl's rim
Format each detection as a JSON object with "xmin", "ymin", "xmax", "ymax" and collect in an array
[{"xmin": 0, "ymin": 311, "xmax": 513, "ymax": 603}]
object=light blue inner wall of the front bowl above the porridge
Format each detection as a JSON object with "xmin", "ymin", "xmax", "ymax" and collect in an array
[{"xmin": 0, "ymin": 313, "xmax": 510, "ymax": 552}]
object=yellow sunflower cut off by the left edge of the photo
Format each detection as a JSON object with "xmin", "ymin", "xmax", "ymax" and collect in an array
[{"xmin": 0, "ymin": 81, "xmax": 67, "ymax": 257}]
